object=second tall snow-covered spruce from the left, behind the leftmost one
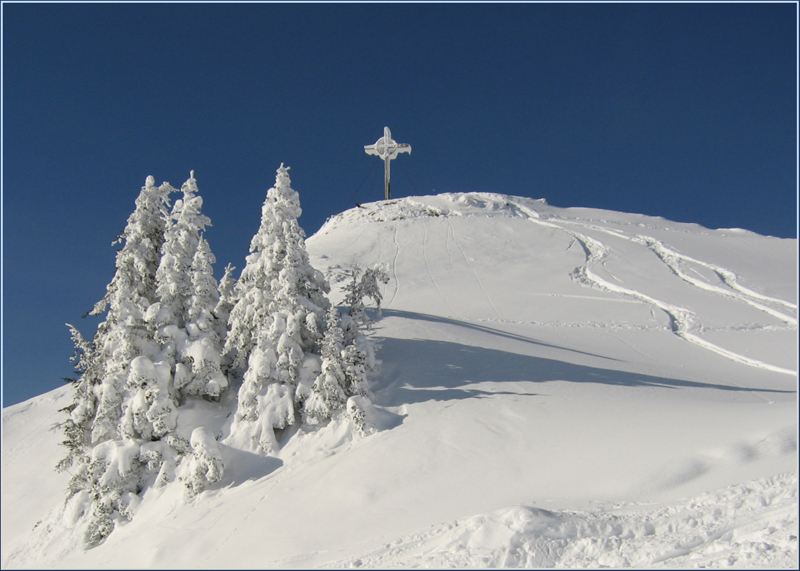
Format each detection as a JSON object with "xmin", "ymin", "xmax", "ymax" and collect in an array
[{"xmin": 122, "ymin": 171, "xmax": 228, "ymax": 496}]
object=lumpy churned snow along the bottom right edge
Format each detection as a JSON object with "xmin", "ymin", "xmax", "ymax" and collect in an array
[{"xmin": 329, "ymin": 473, "xmax": 798, "ymax": 568}]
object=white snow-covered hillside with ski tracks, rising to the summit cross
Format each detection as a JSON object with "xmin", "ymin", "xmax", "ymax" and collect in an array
[{"xmin": 2, "ymin": 193, "xmax": 798, "ymax": 568}]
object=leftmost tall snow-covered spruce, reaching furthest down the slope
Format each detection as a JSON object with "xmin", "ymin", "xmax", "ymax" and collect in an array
[{"xmin": 57, "ymin": 177, "xmax": 174, "ymax": 544}]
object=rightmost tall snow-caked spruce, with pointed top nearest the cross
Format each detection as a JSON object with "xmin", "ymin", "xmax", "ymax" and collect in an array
[{"xmin": 225, "ymin": 164, "xmax": 330, "ymax": 454}]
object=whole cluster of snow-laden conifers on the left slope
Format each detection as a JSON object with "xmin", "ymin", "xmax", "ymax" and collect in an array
[{"xmin": 57, "ymin": 165, "xmax": 388, "ymax": 545}]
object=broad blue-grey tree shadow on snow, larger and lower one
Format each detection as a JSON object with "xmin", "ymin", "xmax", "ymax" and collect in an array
[{"xmin": 373, "ymin": 338, "xmax": 795, "ymax": 406}]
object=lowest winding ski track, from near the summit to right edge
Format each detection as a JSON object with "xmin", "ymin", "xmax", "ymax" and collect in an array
[{"xmin": 516, "ymin": 204, "xmax": 797, "ymax": 378}]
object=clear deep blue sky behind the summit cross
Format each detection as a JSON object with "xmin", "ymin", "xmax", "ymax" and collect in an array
[{"xmin": 3, "ymin": 3, "xmax": 797, "ymax": 406}]
